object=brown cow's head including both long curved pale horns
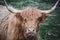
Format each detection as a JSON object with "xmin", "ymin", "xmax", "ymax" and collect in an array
[{"xmin": 4, "ymin": 0, "xmax": 59, "ymax": 39}]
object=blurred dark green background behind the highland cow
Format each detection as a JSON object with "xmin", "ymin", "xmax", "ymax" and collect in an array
[{"xmin": 0, "ymin": 0, "xmax": 60, "ymax": 40}]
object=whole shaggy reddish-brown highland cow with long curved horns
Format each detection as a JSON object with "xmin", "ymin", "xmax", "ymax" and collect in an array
[{"xmin": 0, "ymin": 0, "xmax": 59, "ymax": 40}]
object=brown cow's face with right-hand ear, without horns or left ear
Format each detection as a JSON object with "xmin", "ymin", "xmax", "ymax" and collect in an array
[{"xmin": 21, "ymin": 7, "xmax": 47, "ymax": 38}]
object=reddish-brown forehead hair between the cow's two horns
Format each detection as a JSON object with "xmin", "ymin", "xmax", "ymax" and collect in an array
[{"xmin": 21, "ymin": 7, "xmax": 42, "ymax": 20}]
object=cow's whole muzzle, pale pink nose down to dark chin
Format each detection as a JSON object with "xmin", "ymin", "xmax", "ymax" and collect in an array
[{"xmin": 25, "ymin": 27, "xmax": 36, "ymax": 39}]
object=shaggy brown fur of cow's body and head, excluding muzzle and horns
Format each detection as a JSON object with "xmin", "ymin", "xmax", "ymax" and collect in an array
[{"xmin": 0, "ymin": 7, "xmax": 47, "ymax": 40}]
